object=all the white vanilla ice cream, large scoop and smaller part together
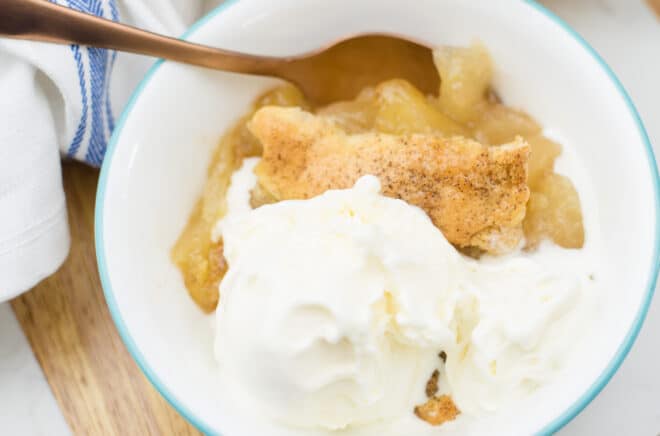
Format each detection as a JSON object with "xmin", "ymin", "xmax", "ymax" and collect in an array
[{"xmin": 214, "ymin": 164, "xmax": 593, "ymax": 429}]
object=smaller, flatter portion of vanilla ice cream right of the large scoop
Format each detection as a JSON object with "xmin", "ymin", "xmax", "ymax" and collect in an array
[{"xmin": 445, "ymin": 249, "xmax": 592, "ymax": 415}]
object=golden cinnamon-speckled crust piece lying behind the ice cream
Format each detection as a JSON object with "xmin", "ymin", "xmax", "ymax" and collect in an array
[{"xmin": 249, "ymin": 107, "xmax": 529, "ymax": 253}]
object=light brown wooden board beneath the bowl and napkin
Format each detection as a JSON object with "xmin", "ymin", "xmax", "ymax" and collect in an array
[{"xmin": 12, "ymin": 163, "xmax": 199, "ymax": 436}]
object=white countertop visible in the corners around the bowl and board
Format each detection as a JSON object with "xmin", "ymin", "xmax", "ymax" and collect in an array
[{"xmin": 0, "ymin": 0, "xmax": 660, "ymax": 436}]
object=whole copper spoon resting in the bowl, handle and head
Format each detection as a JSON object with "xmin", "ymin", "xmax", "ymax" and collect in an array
[{"xmin": 0, "ymin": 0, "xmax": 440, "ymax": 104}]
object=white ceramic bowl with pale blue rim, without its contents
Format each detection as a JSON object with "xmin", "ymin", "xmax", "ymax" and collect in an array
[{"xmin": 96, "ymin": 0, "xmax": 659, "ymax": 436}]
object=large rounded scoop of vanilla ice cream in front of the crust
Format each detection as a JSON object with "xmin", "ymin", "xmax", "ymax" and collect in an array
[{"xmin": 216, "ymin": 176, "xmax": 461, "ymax": 429}]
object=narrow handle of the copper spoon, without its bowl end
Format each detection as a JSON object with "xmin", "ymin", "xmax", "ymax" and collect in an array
[{"xmin": 0, "ymin": 0, "xmax": 286, "ymax": 75}]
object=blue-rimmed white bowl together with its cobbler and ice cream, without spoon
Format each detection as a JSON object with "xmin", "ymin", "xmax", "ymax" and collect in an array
[{"xmin": 97, "ymin": 2, "xmax": 657, "ymax": 435}]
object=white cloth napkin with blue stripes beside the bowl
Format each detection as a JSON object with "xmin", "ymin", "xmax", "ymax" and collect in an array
[{"xmin": 0, "ymin": 0, "xmax": 217, "ymax": 302}]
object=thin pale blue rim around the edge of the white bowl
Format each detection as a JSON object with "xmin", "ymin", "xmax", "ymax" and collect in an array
[{"xmin": 94, "ymin": 0, "xmax": 660, "ymax": 435}]
